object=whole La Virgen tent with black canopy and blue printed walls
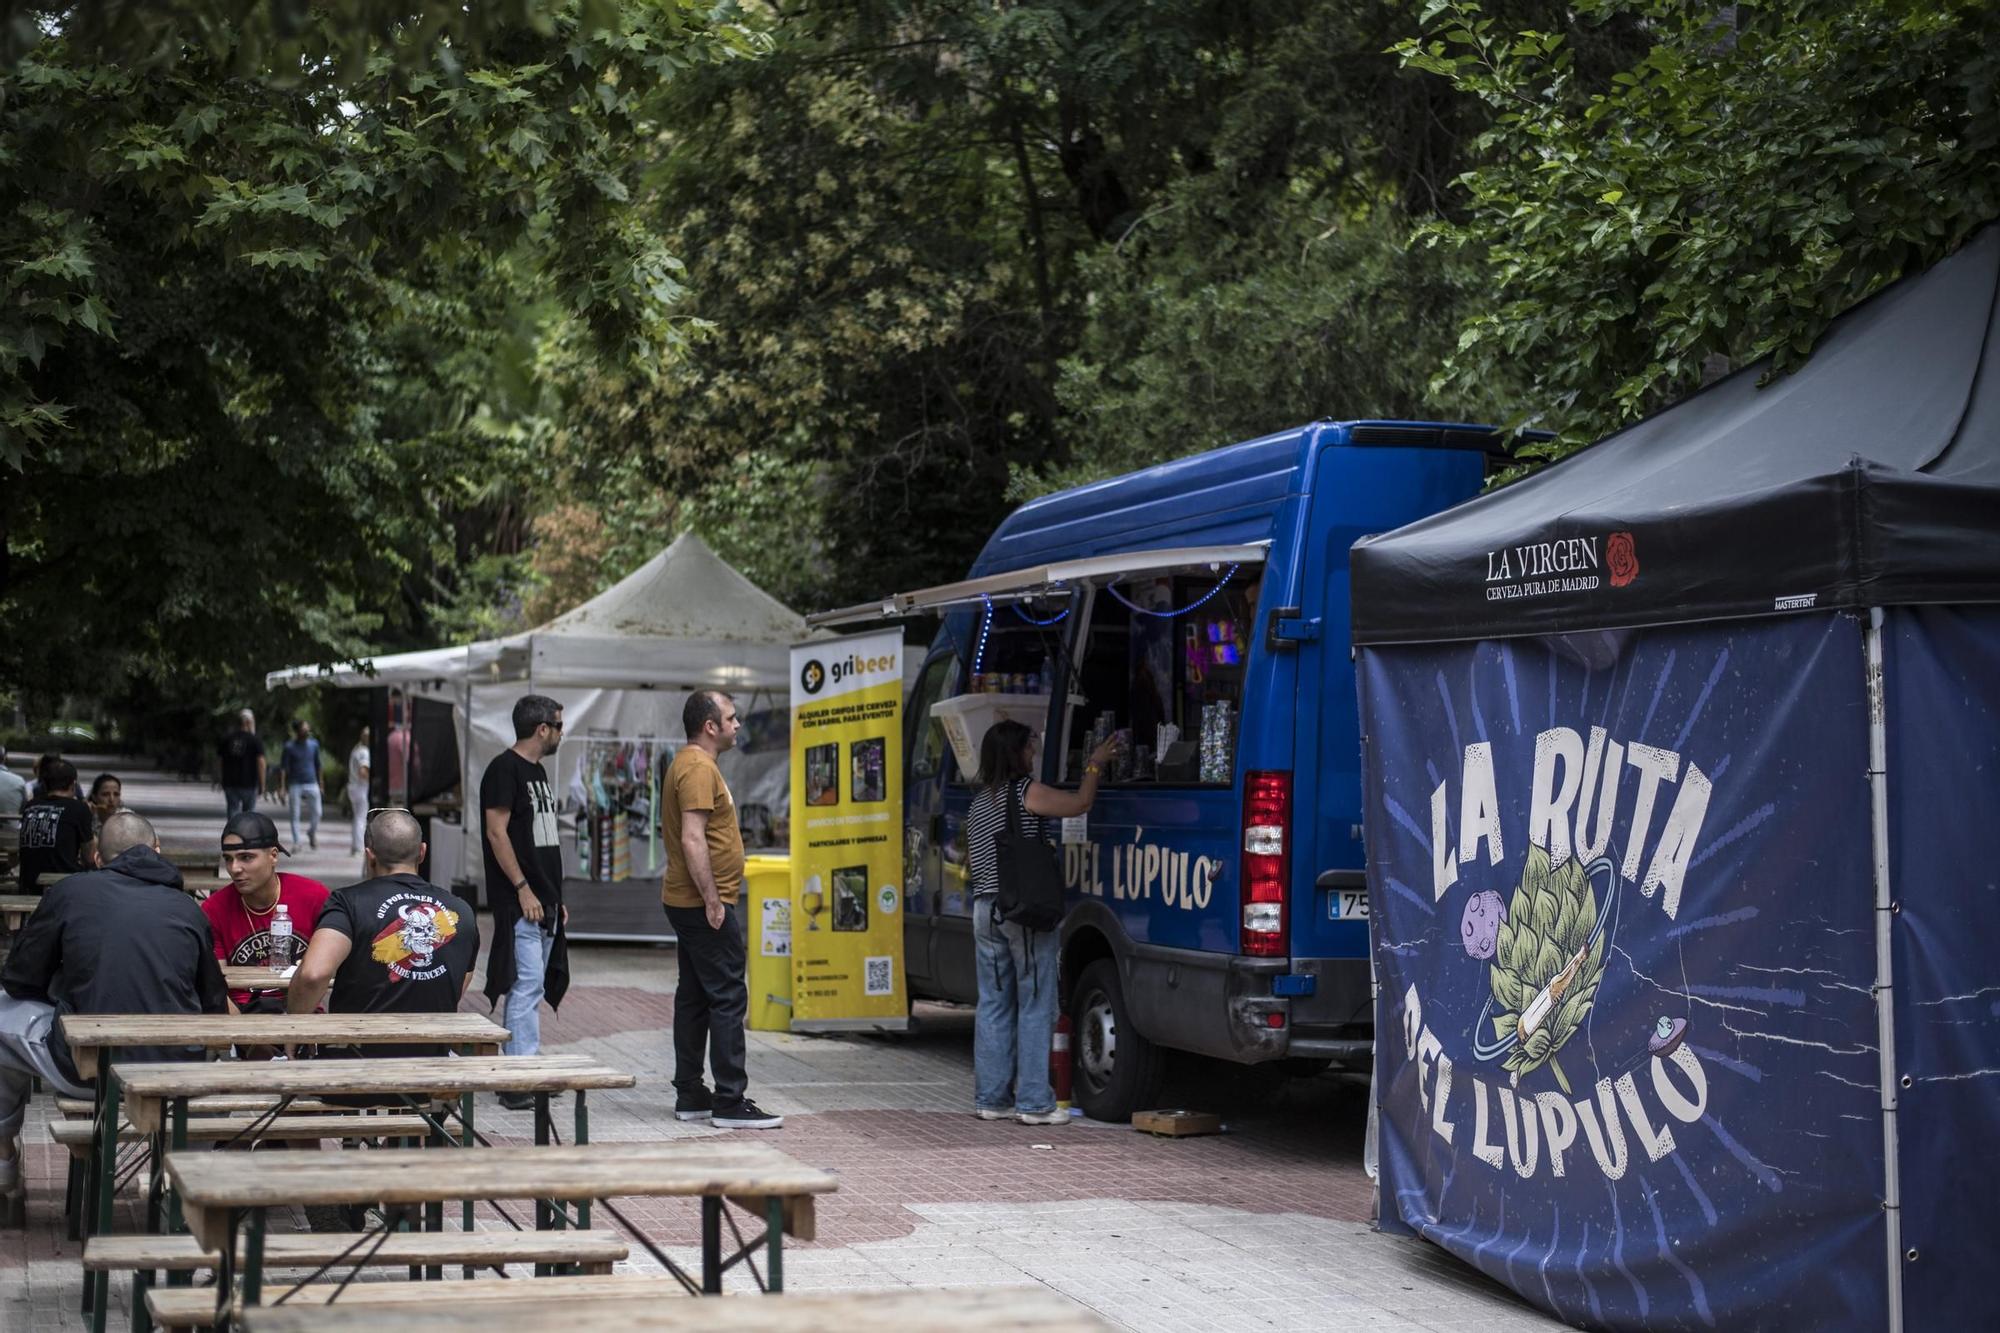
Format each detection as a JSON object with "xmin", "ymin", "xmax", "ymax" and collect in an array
[{"xmin": 1352, "ymin": 228, "xmax": 2000, "ymax": 1329}]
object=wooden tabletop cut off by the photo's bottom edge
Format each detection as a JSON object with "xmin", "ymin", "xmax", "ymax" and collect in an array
[{"xmin": 242, "ymin": 1279, "xmax": 1114, "ymax": 1333}]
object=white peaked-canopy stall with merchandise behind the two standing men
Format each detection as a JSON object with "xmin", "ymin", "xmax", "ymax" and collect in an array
[{"xmin": 266, "ymin": 532, "xmax": 808, "ymax": 941}]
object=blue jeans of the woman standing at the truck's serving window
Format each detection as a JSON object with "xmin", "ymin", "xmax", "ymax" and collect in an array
[{"xmin": 972, "ymin": 893, "xmax": 1058, "ymax": 1115}]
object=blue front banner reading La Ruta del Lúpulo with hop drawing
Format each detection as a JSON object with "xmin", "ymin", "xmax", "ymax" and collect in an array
[{"xmin": 1360, "ymin": 614, "xmax": 1888, "ymax": 1329}]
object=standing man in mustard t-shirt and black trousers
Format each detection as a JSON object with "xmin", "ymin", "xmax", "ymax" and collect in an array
[{"xmin": 660, "ymin": 691, "xmax": 784, "ymax": 1129}]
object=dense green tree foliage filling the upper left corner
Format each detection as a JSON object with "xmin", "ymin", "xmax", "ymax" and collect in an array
[{"xmin": 0, "ymin": 0, "xmax": 758, "ymax": 704}]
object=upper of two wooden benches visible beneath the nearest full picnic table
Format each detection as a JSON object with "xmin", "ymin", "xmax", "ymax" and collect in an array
[{"xmin": 84, "ymin": 1229, "xmax": 632, "ymax": 1280}]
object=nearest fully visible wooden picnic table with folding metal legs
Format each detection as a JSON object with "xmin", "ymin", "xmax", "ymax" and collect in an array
[{"xmin": 166, "ymin": 1139, "xmax": 840, "ymax": 1307}]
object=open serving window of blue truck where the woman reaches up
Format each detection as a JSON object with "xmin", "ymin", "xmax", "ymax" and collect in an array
[{"xmin": 1062, "ymin": 564, "xmax": 1264, "ymax": 787}]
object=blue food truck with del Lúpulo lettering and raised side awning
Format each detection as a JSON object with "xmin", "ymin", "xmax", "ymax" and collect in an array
[{"xmin": 808, "ymin": 420, "xmax": 1498, "ymax": 1119}]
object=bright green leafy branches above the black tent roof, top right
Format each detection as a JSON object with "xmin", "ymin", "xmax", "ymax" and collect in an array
[{"xmin": 1398, "ymin": 0, "xmax": 2000, "ymax": 456}]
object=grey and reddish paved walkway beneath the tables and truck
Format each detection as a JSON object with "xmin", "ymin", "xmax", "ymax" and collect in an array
[{"xmin": 0, "ymin": 752, "xmax": 1560, "ymax": 1333}]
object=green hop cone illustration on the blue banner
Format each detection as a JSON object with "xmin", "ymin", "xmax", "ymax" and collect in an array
[{"xmin": 1488, "ymin": 847, "xmax": 1604, "ymax": 1093}]
